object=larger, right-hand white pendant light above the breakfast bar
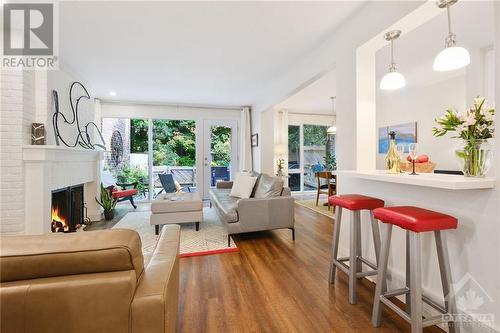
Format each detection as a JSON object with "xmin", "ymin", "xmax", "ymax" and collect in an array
[{"xmin": 433, "ymin": 0, "xmax": 470, "ymax": 72}]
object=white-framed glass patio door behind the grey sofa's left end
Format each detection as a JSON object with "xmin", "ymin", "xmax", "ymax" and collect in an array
[{"xmin": 203, "ymin": 120, "xmax": 238, "ymax": 198}]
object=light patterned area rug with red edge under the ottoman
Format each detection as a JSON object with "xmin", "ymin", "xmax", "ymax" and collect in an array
[{"xmin": 113, "ymin": 207, "xmax": 239, "ymax": 257}]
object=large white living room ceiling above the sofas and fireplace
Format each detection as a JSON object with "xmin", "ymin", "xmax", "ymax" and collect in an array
[{"xmin": 59, "ymin": 1, "xmax": 363, "ymax": 105}]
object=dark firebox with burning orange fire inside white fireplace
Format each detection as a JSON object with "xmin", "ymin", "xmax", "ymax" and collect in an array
[{"xmin": 51, "ymin": 185, "xmax": 84, "ymax": 232}]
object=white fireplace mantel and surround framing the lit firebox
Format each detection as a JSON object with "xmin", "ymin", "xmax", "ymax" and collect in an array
[{"xmin": 23, "ymin": 145, "xmax": 104, "ymax": 234}]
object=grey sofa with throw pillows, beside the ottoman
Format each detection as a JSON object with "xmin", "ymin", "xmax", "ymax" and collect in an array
[{"xmin": 210, "ymin": 174, "xmax": 295, "ymax": 246}]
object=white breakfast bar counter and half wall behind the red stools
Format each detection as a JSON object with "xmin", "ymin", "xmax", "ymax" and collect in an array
[{"xmin": 336, "ymin": 170, "xmax": 500, "ymax": 329}]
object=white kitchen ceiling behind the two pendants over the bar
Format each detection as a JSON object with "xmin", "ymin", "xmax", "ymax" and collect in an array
[{"xmin": 376, "ymin": 1, "xmax": 495, "ymax": 88}]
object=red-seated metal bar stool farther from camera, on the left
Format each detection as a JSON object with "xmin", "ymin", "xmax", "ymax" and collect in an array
[{"xmin": 328, "ymin": 194, "xmax": 384, "ymax": 304}]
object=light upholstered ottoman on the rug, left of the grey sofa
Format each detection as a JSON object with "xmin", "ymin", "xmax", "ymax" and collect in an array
[{"xmin": 150, "ymin": 193, "xmax": 203, "ymax": 235}]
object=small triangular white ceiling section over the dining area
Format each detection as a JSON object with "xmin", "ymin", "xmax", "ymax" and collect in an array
[{"xmin": 275, "ymin": 70, "xmax": 336, "ymax": 114}]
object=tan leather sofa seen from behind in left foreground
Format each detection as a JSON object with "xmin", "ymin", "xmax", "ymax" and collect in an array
[{"xmin": 0, "ymin": 225, "xmax": 180, "ymax": 333}]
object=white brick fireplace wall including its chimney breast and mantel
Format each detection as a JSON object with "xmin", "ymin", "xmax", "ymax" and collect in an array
[{"xmin": 0, "ymin": 69, "xmax": 103, "ymax": 235}]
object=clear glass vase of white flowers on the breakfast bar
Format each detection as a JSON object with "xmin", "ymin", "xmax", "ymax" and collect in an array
[{"xmin": 432, "ymin": 97, "xmax": 495, "ymax": 177}]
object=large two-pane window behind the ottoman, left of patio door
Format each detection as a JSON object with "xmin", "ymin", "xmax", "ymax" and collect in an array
[{"xmin": 102, "ymin": 118, "xmax": 196, "ymax": 200}]
